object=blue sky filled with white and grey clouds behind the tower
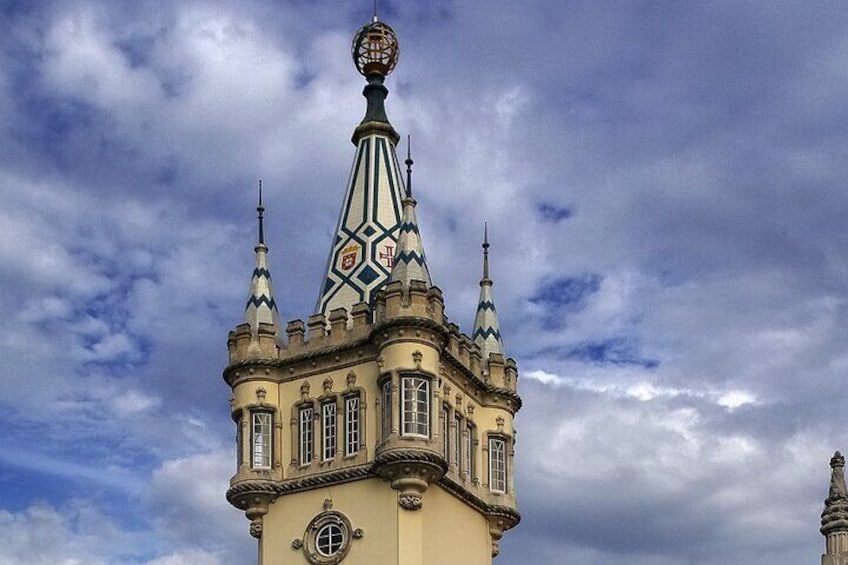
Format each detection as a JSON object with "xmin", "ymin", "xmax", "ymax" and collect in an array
[{"xmin": 0, "ymin": 0, "xmax": 848, "ymax": 565}]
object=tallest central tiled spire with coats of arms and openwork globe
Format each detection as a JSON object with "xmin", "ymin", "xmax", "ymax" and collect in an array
[{"xmin": 315, "ymin": 20, "xmax": 404, "ymax": 315}]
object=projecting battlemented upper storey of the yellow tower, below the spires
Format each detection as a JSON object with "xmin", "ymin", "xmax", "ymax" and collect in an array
[{"xmin": 224, "ymin": 281, "xmax": 521, "ymax": 552}]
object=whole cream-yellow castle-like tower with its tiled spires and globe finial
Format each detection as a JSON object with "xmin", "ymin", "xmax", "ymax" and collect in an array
[{"xmin": 224, "ymin": 17, "xmax": 521, "ymax": 565}]
